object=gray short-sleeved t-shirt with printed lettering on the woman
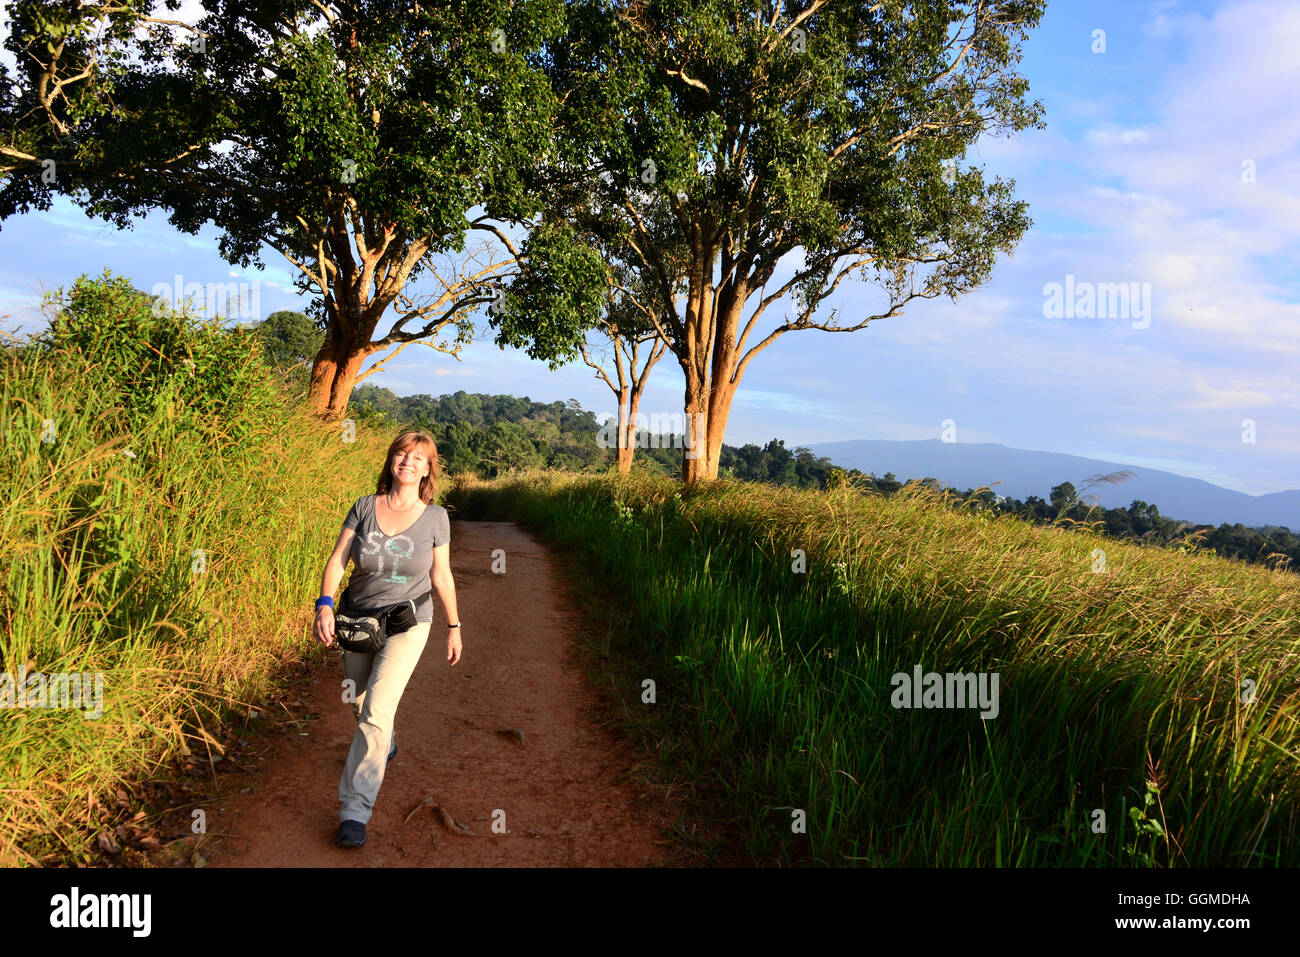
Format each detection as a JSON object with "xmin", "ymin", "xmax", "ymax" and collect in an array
[{"xmin": 343, "ymin": 495, "xmax": 451, "ymax": 622}]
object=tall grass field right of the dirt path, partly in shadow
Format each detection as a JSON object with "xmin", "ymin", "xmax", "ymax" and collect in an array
[{"xmin": 449, "ymin": 473, "xmax": 1300, "ymax": 867}]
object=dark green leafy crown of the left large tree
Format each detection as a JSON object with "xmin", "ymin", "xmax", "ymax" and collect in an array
[{"xmin": 1, "ymin": 0, "xmax": 564, "ymax": 254}]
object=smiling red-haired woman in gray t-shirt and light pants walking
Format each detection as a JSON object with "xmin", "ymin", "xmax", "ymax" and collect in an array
[{"xmin": 315, "ymin": 430, "xmax": 460, "ymax": 848}]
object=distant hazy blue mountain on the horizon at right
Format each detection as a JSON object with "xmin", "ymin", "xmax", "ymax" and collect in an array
[{"xmin": 805, "ymin": 438, "xmax": 1300, "ymax": 531}]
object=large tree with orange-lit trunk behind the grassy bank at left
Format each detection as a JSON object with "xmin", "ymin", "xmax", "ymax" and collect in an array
[{"xmin": 0, "ymin": 0, "xmax": 574, "ymax": 417}]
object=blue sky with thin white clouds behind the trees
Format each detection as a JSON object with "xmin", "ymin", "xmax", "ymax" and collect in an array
[{"xmin": 0, "ymin": 0, "xmax": 1300, "ymax": 494}]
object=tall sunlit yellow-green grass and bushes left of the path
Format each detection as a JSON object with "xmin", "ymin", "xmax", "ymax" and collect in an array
[{"xmin": 0, "ymin": 274, "xmax": 390, "ymax": 865}]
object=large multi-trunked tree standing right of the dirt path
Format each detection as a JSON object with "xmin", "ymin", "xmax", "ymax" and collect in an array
[{"xmin": 495, "ymin": 0, "xmax": 1044, "ymax": 485}]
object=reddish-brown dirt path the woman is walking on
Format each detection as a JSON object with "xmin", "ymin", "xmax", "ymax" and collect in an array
[{"xmin": 203, "ymin": 521, "xmax": 680, "ymax": 867}]
